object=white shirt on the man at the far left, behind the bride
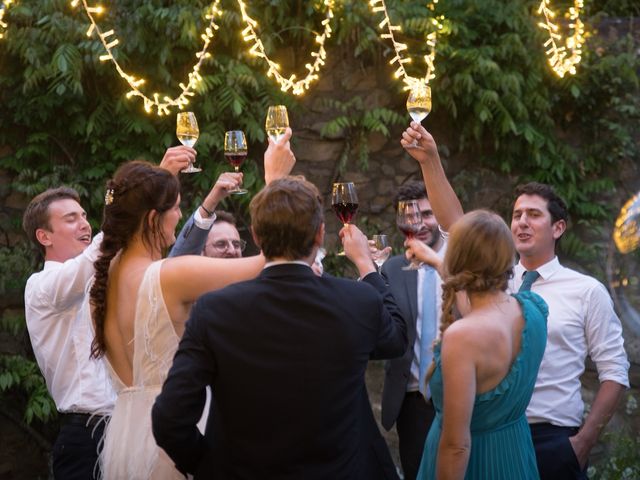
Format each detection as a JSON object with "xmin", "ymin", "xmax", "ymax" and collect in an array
[{"xmin": 24, "ymin": 234, "xmax": 116, "ymax": 414}]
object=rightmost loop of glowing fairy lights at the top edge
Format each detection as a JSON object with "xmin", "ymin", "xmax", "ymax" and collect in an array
[{"xmin": 538, "ymin": 0, "xmax": 585, "ymax": 78}]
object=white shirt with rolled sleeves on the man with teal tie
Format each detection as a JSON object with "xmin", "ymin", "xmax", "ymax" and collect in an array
[{"xmin": 510, "ymin": 257, "xmax": 629, "ymax": 427}]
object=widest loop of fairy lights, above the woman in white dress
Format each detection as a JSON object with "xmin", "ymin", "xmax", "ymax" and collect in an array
[{"xmin": 71, "ymin": 0, "xmax": 222, "ymax": 115}]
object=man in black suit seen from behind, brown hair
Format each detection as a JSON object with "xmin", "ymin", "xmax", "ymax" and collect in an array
[{"xmin": 152, "ymin": 177, "xmax": 407, "ymax": 480}]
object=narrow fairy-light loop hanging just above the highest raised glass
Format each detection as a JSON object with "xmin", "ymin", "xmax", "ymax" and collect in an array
[{"xmin": 369, "ymin": 0, "xmax": 444, "ymax": 90}]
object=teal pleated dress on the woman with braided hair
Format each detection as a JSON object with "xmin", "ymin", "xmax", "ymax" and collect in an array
[{"xmin": 418, "ymin": 291, "xmax": 549, "ymax": 480}]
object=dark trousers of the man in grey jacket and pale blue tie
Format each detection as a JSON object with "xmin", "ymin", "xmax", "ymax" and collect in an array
[{"xmin": 396, "ymin": 392, "xmax": 435, "ymax": 480}]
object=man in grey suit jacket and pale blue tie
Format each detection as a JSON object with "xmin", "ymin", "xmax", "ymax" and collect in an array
[{"xmin": 382, "ymin": 181, "xmax": 446, "ymax": 480}]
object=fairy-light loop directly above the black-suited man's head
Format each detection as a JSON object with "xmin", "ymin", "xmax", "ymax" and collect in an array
[{"xmin": 238, "ymin": 0, "xmax": 334, "ymax": 95}]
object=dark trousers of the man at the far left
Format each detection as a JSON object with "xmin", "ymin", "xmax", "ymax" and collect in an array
[{"xmin": 52, "ymin": 414, "xmax": 104, "ymax": 480}]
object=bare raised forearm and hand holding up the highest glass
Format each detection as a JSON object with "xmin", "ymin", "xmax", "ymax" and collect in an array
[{"xmin": 400, "ymin": 122, "xmax": 463, "ymax": 232}]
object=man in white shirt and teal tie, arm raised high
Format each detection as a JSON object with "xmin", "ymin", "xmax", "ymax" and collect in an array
[{"xmin": 401, "ymin": 123, "xmax": 629, "ymax": 480}]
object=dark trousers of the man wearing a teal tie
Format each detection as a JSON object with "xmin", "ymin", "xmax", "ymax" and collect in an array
[{"xmin": 529, "ymin": 423, "xmax": 587, "ymax": 480}]
